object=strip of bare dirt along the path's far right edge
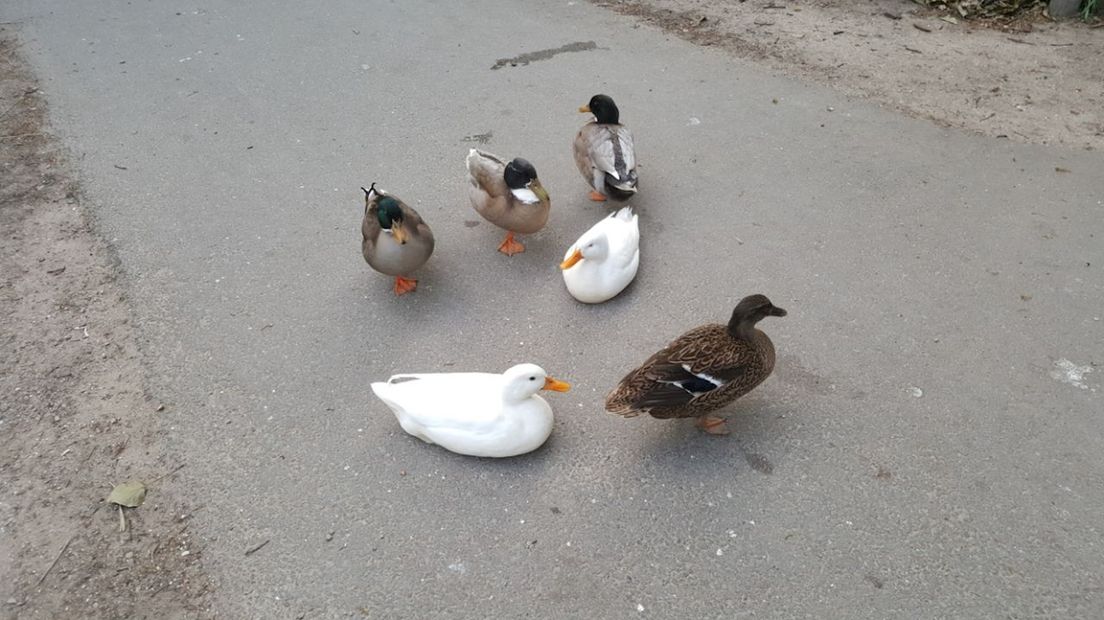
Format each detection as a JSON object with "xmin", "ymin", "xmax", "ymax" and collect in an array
[{"xmin": 594, "ymin": 0, "xmax": 1104, "ymax": 149}]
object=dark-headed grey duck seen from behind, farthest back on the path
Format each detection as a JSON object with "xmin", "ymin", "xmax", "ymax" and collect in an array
[{"xmin": 575, "ymin": 95, "xmax": 637, "ymax": 202}]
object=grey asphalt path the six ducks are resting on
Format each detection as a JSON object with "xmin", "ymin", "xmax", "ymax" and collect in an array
[{"xmin": 0, "ymin": 0, "xmax": 1104, "ymax": 618}]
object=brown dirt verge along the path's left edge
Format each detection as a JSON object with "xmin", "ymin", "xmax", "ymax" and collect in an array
[{"xmin": 0, "ymin": 32, "xmax": 209, "ymax": 619}]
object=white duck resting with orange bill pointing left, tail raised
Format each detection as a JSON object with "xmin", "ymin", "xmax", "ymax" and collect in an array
[{"xmin": 560, "ymin": 206, "xmax": 640, "ymax": 303}]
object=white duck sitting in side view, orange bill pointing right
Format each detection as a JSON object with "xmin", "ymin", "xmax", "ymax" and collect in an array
[{"xmin": 372, "ymin": 363, "xmax": 571, "ymax": 458}]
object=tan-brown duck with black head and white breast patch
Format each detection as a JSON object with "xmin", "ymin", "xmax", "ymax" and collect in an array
[{"xmin": 467, "ymin": 149, "xmax": 552, "ymax": 256}]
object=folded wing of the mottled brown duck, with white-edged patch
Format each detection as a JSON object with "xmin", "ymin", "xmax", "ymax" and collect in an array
[{"xmin": 606, "ymin": 324, "xmax": 763, "ymax": 417}]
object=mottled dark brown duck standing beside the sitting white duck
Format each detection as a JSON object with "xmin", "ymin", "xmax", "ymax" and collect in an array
[{"xmin": 606, "ymin": 295, "xmax": 786, "ymax": 435}]
